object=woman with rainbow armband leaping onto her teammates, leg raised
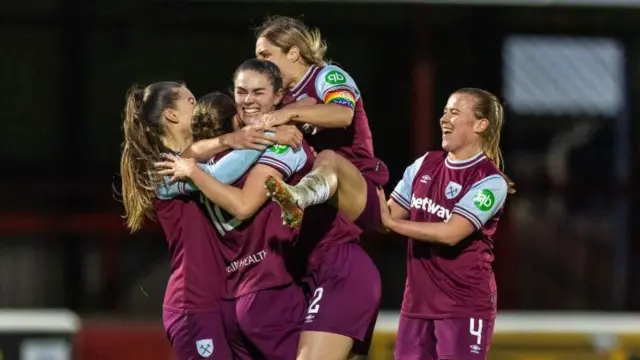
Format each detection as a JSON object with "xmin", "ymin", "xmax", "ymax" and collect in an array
[{"xmin": 255, "ymin": 16, "xmax": 389, "ymax": 242}]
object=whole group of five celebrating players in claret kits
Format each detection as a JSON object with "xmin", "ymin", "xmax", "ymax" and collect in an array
[{"xmin": 121, "ymin": 17, "xmax": 514, "ymax": 360}]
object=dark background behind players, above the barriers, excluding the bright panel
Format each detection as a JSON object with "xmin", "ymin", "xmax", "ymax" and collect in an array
[{"xmin": 0, "ymin": 0, "xmax": 640, "ymax": 316}]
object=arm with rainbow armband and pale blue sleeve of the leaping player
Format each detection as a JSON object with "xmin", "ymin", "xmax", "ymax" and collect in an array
[{"xmin": 282, "ymin": 65, "xmax": 360, "ymax": 128}]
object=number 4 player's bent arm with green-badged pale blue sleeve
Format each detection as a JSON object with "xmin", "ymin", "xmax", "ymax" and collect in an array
[{"xmin": 385, "ymin": 175, "xmax": 508, "ymax": 246}]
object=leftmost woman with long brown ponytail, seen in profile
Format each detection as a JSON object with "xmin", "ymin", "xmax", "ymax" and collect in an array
[{"xmin": 120, "ymin": 81, "xmax": 231, "ymax": 360}]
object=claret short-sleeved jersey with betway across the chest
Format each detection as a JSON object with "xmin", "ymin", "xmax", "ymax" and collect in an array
[{"xmin": 391, "ymin": 151, "xmax": 508, "ymax": 319}]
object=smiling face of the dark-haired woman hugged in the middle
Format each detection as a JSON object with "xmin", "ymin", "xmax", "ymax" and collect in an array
[{"xmin": 233, "ymin": 70, "xmax": 282, "ymax": 125}]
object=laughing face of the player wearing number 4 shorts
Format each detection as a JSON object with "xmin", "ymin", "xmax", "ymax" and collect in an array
[{"xmin": 440, "ymin": 93, "xmax": 488, "ymax": 152}]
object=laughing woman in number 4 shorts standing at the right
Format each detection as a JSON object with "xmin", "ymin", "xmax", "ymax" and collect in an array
[{"xmin": 379, "ymin": 88, "xmax": 513, "ymax": 360}]
